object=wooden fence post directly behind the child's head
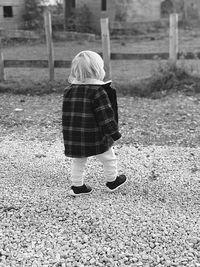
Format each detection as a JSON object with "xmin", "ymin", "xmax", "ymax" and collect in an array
[{"xmin": 100, "ymin": 18, "xmax": 111, "ymax": 80}]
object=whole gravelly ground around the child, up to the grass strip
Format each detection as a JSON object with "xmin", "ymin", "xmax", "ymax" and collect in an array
[{"xmin": 0, "ymin": 94, "xmax": 200, "ymax": 267}]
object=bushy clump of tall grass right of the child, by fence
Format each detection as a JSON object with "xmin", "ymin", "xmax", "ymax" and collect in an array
[{"xmin": 116, "ymin": 60, "xmax": 200, "ymax": 98}]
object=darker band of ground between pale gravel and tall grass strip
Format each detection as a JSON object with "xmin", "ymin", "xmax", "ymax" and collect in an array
[{"xmin": 0, "ymin": 91, "xmax": 200, "ymax": 147}]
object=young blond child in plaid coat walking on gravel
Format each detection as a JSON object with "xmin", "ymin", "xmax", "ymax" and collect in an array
[{"xmin": 62, "ymin": 51, "xmax": 126, "ymax": 196}]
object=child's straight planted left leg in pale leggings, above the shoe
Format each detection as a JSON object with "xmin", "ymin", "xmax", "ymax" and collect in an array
[{"xmin": 71, "ymin": 158, "xmax": 87, "ymax": 186}]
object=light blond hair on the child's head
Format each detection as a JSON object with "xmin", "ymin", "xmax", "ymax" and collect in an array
[{"xmin": 68, "ymin": 50, "xmax": 105, "ymax": 83}]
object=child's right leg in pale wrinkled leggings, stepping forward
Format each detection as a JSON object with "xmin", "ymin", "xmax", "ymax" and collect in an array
[{"xmin": 96, "ymin": 148, "xmax": 118, "ymax": 182}]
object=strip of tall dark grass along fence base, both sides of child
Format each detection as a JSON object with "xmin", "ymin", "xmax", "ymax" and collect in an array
[{"xmin": 0, "ymin": 61, "xmax": 200, "ymax": 98}]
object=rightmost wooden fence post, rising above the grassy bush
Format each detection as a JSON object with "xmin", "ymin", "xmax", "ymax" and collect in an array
[{"xmin": 169, "ymin": 13, "xmax": 178, "ymax": 64}]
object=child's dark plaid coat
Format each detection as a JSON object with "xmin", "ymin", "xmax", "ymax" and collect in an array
[{"xmin": 62, "ymin": 84, "xmax": 121, "ymax": 158}]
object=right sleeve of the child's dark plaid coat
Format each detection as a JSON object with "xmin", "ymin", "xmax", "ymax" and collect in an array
[{"xmin": 93, "ymin": 87, "xmax": 121, "ymax": 141}]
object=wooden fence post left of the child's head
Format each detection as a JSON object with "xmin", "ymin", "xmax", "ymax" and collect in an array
[{"xmin": 44, "ymin": 10, "xmax": 54, "ymax": 81}]
